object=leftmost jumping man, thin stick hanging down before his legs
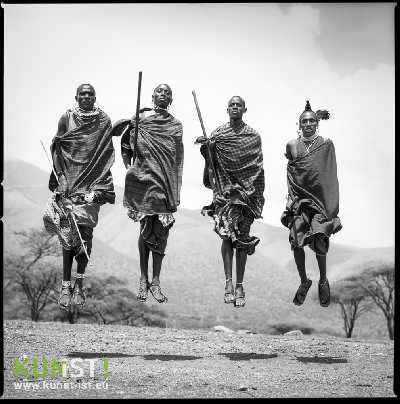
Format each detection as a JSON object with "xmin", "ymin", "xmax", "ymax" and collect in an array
[{"xmin": 43, "ymin": 84, "xmax": 115, "ymax": 310}]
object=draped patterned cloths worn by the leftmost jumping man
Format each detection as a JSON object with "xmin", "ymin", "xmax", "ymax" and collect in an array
[{"xmin": 43, "ymin": 109, "xmax": 115, "ymax": 250}]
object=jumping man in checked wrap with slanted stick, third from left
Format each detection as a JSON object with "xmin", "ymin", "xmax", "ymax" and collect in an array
[{"xmin": 196, "ymin": 96, "xmax": 265, "ymax": 307}]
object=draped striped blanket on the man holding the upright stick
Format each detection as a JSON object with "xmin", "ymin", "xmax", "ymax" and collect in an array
[{"xmin": 123, "ymin": 107, "xmax": 183, "ymax": 215}]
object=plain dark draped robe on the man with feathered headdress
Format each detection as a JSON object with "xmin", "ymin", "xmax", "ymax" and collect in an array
[{"xmin": 281, "ymin": 139, "xmax": 342, "ymax": 255}]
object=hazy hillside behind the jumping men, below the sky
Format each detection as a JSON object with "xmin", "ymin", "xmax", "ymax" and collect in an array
[{"xmin": 4, "ymin": 161, "xmax": 394, "ymax": 337}]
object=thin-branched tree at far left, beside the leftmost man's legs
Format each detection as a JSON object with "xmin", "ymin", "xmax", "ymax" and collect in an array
[{"xmin": 5, "ymin": 228, "xmax": 60, "ymax": 321}]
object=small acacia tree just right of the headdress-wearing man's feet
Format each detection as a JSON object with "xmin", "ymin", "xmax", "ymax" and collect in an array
[{"xmin": 331, "ymin": 278, "xmax": 372, "ymax": 338}]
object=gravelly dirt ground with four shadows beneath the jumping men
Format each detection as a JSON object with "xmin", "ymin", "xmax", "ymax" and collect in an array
[{"xmin": 2, "ymin": 320, "xmax": 395, "ymax": 398}]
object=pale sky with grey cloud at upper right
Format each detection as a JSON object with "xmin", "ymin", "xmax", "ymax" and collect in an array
[{"xmin": 3, "ymin": 3, "xmax": 395, "ymax": 247}]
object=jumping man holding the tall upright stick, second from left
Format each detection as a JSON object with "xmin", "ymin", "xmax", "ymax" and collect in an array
[{"xmin": 113, "ymin": 84, "xmax": 183, "ymax": 303}]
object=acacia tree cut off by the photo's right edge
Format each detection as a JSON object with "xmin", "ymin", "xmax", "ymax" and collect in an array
[{"xmin": 361, "ymin": 263, "xmax": 394, "ymax": 339}]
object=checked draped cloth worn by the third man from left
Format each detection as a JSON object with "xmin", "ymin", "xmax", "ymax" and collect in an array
[{"xmin": 198, "ymin": 122, "xmax": 265, "ymax": 254}]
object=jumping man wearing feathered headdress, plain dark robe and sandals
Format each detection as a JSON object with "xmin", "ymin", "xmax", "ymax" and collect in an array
[{"xmin": 281, "ymin": 101, "xmax": 342, "ymax": 307}]
